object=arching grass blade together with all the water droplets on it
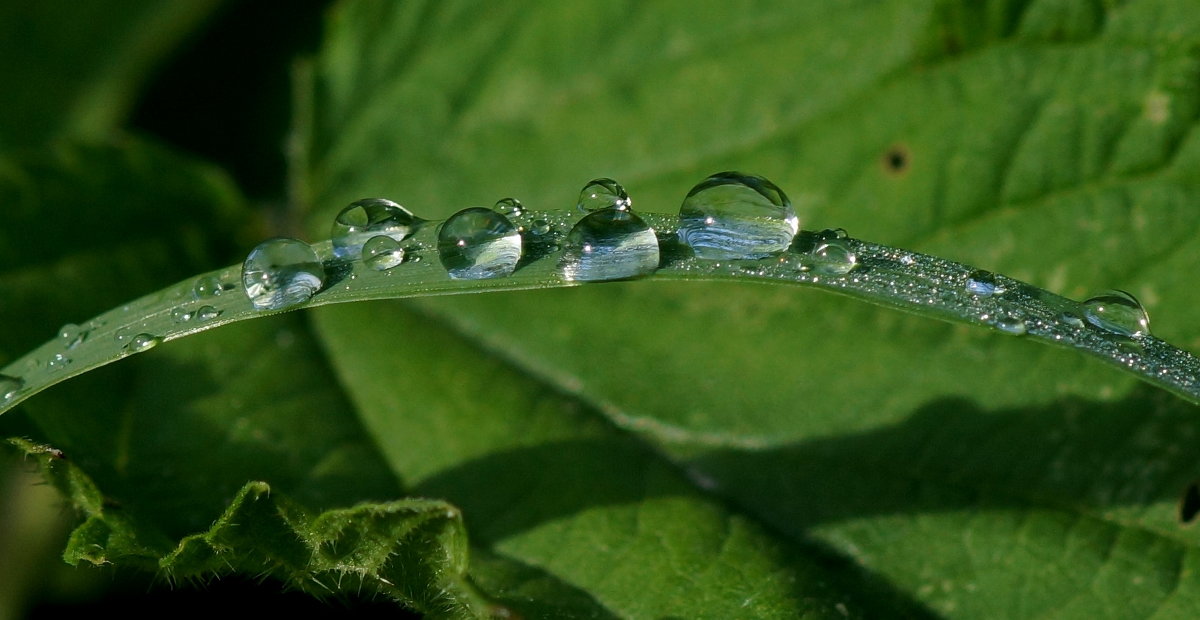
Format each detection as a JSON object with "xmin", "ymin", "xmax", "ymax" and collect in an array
[{"xmin": 0, "ymin": 166, "xmax": 1200, "ymax": 414}]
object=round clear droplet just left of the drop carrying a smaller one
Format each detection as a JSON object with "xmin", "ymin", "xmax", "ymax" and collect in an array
[{"xmin": 438, "ymin": 206, "xmax": 521, "ymax": 279}]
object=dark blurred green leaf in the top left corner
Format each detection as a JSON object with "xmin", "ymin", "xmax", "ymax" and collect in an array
[{"xmin": 0, "ymin": 0, "xmax": 220, "ymax": 149}]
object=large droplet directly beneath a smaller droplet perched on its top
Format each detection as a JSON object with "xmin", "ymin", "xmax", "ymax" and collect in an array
[{"xmin": 559, "ymin": 209, "xmax": 659, "ymax": 282}]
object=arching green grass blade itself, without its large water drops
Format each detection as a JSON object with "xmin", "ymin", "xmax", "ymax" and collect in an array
[{"xmin": 0, "ymin": 210, "xmax": 1200, "ymax": 413}]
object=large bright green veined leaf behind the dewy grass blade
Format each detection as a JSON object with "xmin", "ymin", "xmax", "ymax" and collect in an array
[{"xmin": 295, "ymin": 0, "xmax": 1200, "ymax": 618}]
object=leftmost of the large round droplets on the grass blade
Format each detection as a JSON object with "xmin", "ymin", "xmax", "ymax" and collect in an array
[{"xmin": 241, "ymin": 237, "xmax": 325, "ymax": 311}]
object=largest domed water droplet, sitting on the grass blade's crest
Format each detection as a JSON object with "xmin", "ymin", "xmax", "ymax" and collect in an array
[{"xmin": 679, "ymin": 173, "xmax": 799, "ymax": 259}]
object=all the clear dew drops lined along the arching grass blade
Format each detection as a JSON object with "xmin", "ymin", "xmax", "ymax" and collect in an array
[{"xmin": 0, "ymin": 171, "xmax": 1150, "ymax": 404}]
